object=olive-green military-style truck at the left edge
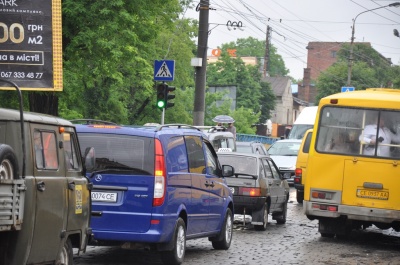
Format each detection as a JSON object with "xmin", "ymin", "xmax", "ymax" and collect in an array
[{"xmin": 0, "ymin": 100, "xmax": 94, "ymax": 265}]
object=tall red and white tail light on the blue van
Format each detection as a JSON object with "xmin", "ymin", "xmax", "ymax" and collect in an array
[{"xmin": 153, "ymin": 139, "xmax": 166, "ymax": 206}]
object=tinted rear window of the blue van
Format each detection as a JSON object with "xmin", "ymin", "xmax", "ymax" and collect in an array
[{"xmin": 78, "ymin": 133, "xmax": 154, "ymax": 175}]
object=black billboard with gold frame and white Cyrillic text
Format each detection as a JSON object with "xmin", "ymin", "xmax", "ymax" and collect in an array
[{"xmin": 0, "ymin": 0, "xmax": 63, "ymax": 91}]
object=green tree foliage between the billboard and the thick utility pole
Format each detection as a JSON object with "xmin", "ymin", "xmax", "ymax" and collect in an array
[{"xmin": 60, "ymin": 0, "xmax": 197, "ymax": 124}]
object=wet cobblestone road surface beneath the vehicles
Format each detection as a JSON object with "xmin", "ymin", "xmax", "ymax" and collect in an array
[{"xmin": 74, "ymin": 188, "xmax": 400, "ymax": 265}]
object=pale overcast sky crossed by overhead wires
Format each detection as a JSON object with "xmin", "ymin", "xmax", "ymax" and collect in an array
[{"xmin": 185, "ymin": 0, "xmax": 400, "ymax": 79}]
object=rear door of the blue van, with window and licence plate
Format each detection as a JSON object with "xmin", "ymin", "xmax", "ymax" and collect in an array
[{"xmin": 78, "ymin": 131, "xmax": 154, "ymax": 234}]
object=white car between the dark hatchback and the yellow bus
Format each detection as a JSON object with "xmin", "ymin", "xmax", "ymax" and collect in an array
[{"xmin": 268, "ymin": 139, "xmax": 301, "ymax": 186}]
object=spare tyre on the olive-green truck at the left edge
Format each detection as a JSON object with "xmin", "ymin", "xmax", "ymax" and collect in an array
[{"xmin": 0, "ymin": 144, "xmax": 20, "ymax": 180}]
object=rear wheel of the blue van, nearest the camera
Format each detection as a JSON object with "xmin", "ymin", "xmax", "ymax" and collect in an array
[{"xmin": 161, "ymin": 218, "xmax": 186, "ymax": 265}]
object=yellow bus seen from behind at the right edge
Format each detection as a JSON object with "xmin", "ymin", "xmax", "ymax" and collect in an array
[{"xmin": 303, "ymin": 88, "xmax": 400, "ymax": 237}]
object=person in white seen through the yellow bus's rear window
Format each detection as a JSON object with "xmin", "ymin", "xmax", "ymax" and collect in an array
[{"xmin": 359, "ymin": 114, "xmax": 400, "ymax": 157}]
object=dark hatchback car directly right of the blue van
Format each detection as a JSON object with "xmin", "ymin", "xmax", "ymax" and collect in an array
[{"xmin": 217, "ymin": 152, "xmax": 289, "ymax": 230}]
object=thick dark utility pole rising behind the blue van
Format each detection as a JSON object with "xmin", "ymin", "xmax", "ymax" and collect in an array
[{"xmin": 193, "ymin": 0, "xmax": 210, "ymax": 126}]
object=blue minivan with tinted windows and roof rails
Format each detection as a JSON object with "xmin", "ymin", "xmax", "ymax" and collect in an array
[{"xmin": 75, "ymin": 123, "xmax": 234, "ymax": 264}]
